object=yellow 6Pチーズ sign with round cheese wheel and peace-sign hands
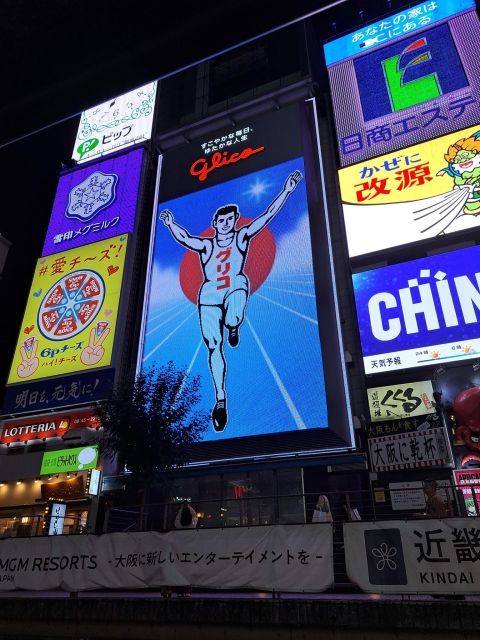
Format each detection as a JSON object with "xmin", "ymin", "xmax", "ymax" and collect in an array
[{"xmin": 8, "ymin": 235, "xmax": 127, "ymax": 384}]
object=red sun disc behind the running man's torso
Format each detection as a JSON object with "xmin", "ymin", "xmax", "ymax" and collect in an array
[{"xmin": 180, "ymin": 217, "xmax": 276, "ymax": 304}]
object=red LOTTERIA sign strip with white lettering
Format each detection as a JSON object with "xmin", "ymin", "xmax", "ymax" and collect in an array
[{"xmin": 0, "ymin": 411, "xmax": 100, "ymax": 444}]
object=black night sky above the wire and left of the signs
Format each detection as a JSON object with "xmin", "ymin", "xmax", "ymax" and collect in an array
[{"xmin": 0, "ymin": 0, "xmax": 406, "ymax": 397}]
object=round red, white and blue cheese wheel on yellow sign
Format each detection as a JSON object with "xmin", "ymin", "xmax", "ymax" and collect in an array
[{"xmin": 37, "ymin": 269, "xmax": 105, "ymax": 340}]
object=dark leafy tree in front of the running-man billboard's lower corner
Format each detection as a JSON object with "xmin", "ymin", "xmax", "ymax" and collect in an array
[{"xmin": 96, "ymin": 361, "xmax": 209, "ymax": 527}]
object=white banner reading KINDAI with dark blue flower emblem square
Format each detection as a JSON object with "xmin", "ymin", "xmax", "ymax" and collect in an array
[{"xmin": 343, "ymin": 518, "xmax": 480, "ymax": 594}]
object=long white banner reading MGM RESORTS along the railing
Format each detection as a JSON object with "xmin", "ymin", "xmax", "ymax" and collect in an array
[{"xmin": 0, "ymin": 523, "xmax": 333, "ymax": 592}]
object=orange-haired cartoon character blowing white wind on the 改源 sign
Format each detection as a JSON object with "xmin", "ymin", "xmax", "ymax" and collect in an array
[{"xmin": 414, "ymin": 131, "xmax": 480, "ymax": 235}]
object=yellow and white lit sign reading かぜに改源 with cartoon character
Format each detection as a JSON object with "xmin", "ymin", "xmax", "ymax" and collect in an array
[{"xmin": 339, "ymin": 125, "xmax": 480, "ymax": 257}]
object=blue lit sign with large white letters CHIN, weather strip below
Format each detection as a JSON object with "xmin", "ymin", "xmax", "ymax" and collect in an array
[{"xmin": 353, "ymin": 246, "xmax": 480, "ymax": 374}]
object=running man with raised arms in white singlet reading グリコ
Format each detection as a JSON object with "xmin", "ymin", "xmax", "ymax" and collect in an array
[{"xmin": 160, "ymin": 171, "xmax": 303, "ymax": 432}]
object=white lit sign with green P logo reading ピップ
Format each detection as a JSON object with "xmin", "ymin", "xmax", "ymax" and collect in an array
[{"xmin": 72, "ymin": 82, "xmax": 157, "ymax": 162}]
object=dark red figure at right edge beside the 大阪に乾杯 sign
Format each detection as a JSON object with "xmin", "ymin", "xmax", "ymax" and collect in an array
[{"xmin": 453, "ymin": 387, "xmax": 480, "ymax": 467}]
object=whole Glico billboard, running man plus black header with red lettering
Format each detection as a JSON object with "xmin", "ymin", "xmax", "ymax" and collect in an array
[{"xmin": 141, "ymin": 107, "xmax": 352, "ymax": 450}]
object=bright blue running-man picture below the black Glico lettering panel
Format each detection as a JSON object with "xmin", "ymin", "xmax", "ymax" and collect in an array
[{"xmin": 142, "ymin": 157, "xmax": 327, "ymax": 439}]
